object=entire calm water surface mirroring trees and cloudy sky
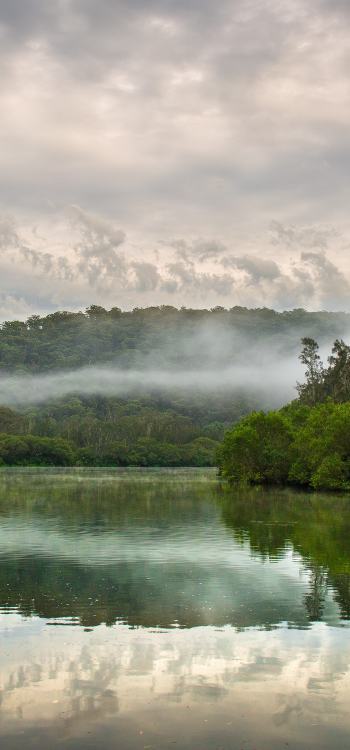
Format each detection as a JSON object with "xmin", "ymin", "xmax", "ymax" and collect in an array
[{"xmin": 0, "ymin": 470, "xmax": 350, "ymax": 750}]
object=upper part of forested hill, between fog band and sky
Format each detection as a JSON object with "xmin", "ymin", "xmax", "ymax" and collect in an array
[{"xmin": 0, "ymin": 305, "xmax": 350, "ymax": 373}]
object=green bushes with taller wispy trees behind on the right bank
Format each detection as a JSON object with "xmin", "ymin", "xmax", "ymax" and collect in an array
[{"xmin": 218, "ymin": 337, "xmax": 350, "ymax": 491}]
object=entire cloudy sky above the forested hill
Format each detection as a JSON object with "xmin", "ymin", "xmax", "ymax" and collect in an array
[{"xmin": 0, "ymin": 0, "xmax": 350, "ymax": 319}]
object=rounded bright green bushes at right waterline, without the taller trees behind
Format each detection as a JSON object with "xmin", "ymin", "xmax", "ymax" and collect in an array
[{"xmin": 218, "ymin": 400, "xmax": 350, "ymax": 490}]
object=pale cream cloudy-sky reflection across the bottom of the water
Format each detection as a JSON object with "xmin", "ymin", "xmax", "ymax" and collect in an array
[{"xmin": 0, "ymin": 615, "xmax": 350, "ymax": 750}]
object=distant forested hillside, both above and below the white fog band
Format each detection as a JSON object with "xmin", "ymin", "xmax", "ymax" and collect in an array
[{"xmin": 0, "ymin": 305, "xmax": 350, "ymax": 466}]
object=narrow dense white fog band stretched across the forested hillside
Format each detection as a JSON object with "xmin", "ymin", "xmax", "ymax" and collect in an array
[{"xmin": 0, "ymin": 359, "xmax": 302, "ymax": 407}]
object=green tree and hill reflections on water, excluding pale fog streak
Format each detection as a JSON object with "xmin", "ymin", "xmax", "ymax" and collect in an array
[{"xmin": 0, "ymin": 472, "xmax": 350, "ymax": 628}]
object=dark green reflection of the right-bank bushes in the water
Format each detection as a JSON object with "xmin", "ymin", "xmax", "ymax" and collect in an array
[{"xmin": 220, "ymin": 488, "xmax": 350, "ymax": 621}]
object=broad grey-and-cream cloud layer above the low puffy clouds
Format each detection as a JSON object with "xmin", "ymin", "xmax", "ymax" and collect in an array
[{"xmin": 0, "ymin": 0, "xmax": 347, "ymax": 234}]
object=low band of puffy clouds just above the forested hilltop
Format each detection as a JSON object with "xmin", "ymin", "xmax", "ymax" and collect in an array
[{"xmin": 0, "ymin": 206, "xmax": 350, "ymax": 317}]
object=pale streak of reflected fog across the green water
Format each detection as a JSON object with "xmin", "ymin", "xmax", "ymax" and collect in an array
[{"xmin": 0, "ymin": 517, "xmax": 300, "ymax": 578}]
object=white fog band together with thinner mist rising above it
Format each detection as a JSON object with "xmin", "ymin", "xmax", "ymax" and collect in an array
[{"xmin": 0, "ymin": 320, "xmax": 338, "ymax": 408}]
